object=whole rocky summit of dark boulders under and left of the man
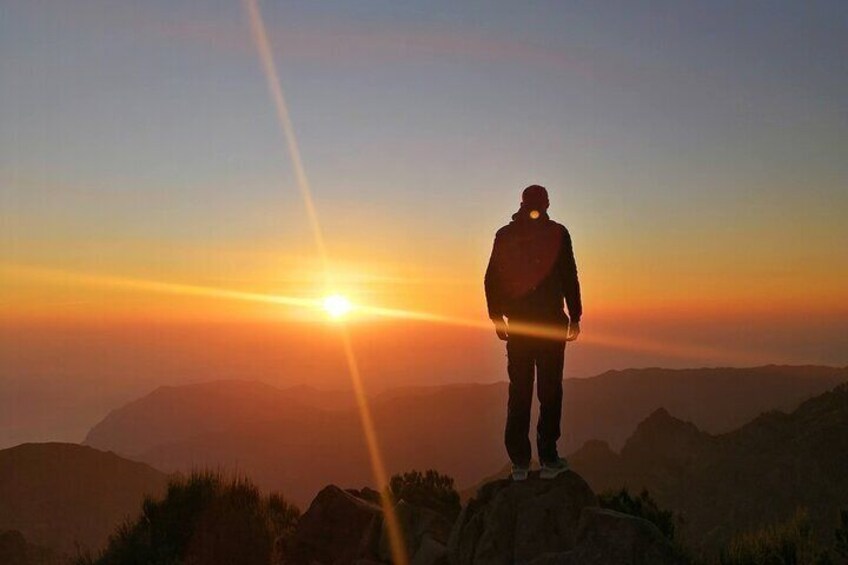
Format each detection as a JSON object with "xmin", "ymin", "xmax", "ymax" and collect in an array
[{"xmin": 281, "ymin": 472, "xmax": 680, "ymax": 565}]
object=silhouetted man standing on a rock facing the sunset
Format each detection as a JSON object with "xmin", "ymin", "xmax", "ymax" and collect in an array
[{"xmin": 485, "ymin": 185, "xmax": 583, "ymax": 481}]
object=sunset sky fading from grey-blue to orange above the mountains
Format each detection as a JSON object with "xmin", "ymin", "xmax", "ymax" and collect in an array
[{"xmin": 0, "ymin": 0, "xmax": 848, "ymax": 442}]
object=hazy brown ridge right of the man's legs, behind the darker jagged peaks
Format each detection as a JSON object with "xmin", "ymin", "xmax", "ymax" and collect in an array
[{"xmin": 563, "ymin": 365, "xmax": 848, "ymax": 451}]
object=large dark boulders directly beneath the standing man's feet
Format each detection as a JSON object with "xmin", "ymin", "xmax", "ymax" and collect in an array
[{"xmin": 449, "ymin": 472, "xmax": 680, "ymax": 565}]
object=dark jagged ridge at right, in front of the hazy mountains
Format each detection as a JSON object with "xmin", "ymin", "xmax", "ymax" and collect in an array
[{"xmin": 570, "ymin": 385, "xmax": 848, "ymax": 549}]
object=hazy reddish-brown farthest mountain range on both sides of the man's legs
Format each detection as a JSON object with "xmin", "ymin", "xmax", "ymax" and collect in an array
[{"xmin": 85, "ymin": 366, "xmax": 848, "ymax": 505}]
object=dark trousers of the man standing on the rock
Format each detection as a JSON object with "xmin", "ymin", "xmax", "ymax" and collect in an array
[{"xmin": 504, "ymin": 336, "xmax": 565, "ymax": 465}]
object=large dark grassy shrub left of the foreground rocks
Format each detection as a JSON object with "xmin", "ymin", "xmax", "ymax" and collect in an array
[{"xmin": 77, "ymin": 472, "xmax": 300, "ymax": 565}]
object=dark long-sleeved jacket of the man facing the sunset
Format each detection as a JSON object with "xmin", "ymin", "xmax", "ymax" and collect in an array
[{"xmin": 485, "ymin": 209, "xmax": 583, "ymax": 323}]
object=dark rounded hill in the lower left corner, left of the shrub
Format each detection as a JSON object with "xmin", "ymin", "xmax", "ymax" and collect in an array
[{"xmin": 0, "ymin": 443, "xmax": 167, "ymax": 552}]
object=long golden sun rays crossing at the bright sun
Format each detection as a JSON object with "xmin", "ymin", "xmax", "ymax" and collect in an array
[{"xmin": 0, "ymin": 5, "xmax": 776, "ymax": 565}]
